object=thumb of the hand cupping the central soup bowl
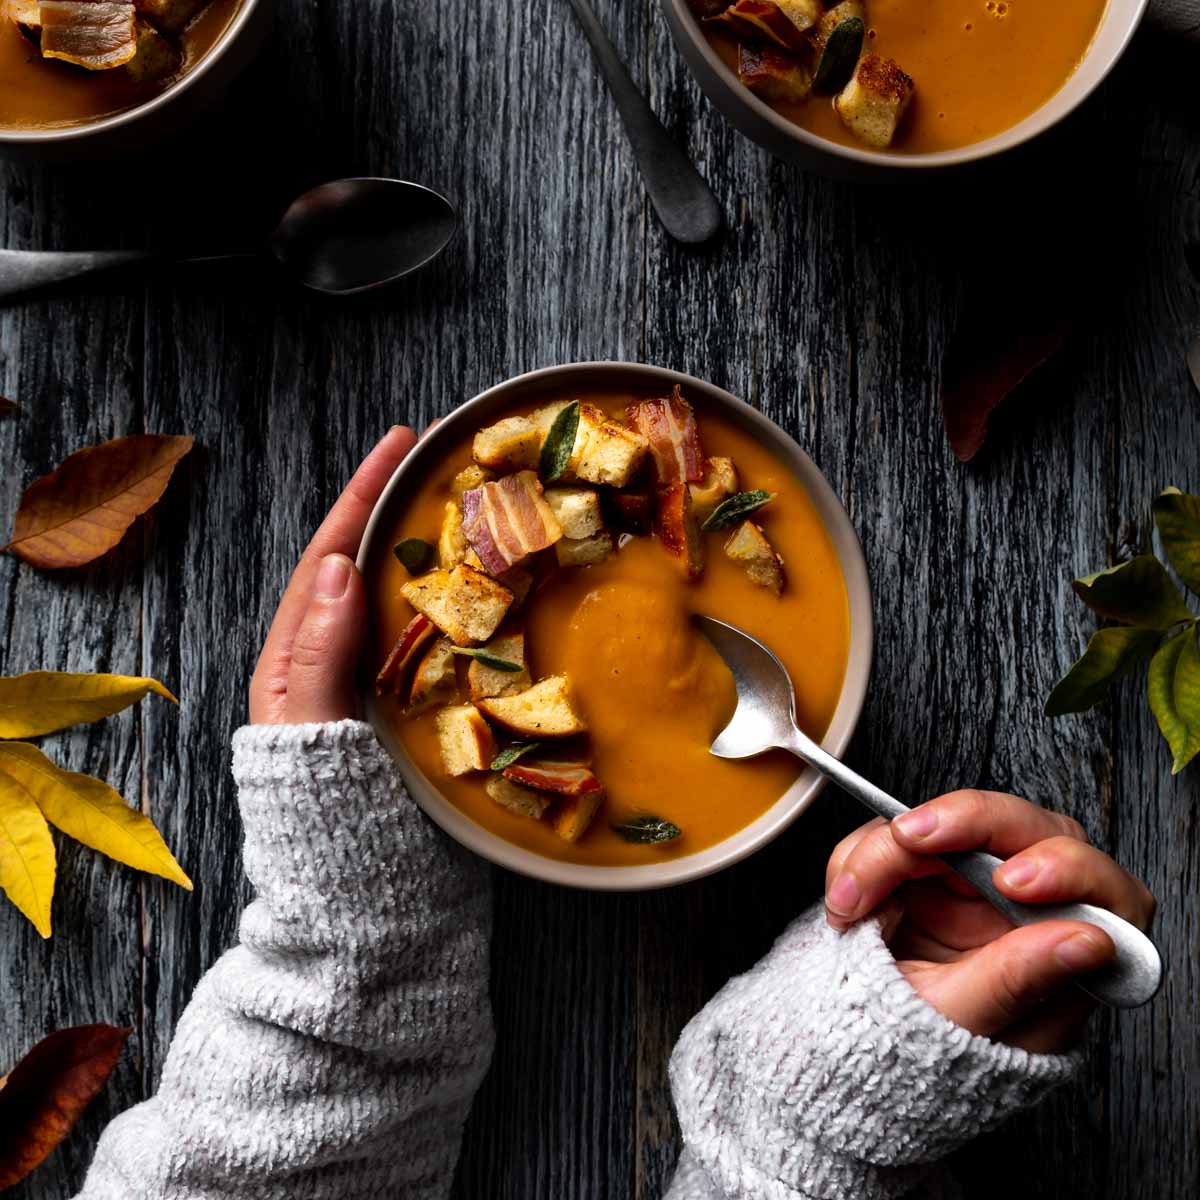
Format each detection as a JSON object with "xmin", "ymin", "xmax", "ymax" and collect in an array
[{"xmin": 283, "ymin": 554, "xmax": 366, "ymax": 725}]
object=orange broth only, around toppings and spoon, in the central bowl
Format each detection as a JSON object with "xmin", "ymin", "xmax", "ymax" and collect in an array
[{"xmin": 371, "ymin": 392, "xmax": 850, "ymax": 866}]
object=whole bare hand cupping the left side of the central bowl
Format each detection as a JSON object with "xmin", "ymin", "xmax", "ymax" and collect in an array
[{"xmin": 250, "ymin": 425, "xmax": 416, "ymax": 725}]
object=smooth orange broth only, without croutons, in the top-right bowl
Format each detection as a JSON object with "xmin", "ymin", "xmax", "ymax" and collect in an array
[{"xmin": 708, "ymin": 0, "xmax": 1108, "ymax": 154}]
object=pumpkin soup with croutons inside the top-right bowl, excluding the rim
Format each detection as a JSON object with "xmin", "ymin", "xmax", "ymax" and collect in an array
[{"xmin": 690, "ymin": 0, "xmax": 1106, "ymax": 154}]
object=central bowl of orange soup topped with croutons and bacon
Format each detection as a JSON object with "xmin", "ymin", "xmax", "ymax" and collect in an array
[{"xmin": 359, "ymin": 362, "xmax": 872, "ymax": 890}]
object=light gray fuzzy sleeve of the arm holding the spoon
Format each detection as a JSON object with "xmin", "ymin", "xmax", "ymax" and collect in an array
[{"xmin": 667, "ymin": 905, "xmax": 1076, "ymax": 1200}]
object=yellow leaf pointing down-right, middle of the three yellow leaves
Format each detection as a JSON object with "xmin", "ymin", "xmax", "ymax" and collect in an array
[{"xmin": 0, "ymin": 742, "xmax": 192, "ymax": 892}]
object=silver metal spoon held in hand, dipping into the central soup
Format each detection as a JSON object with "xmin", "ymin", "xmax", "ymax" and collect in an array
[{"xmin": 692, "ymin": 616, "xmax": 1163, "ymax": 1008}]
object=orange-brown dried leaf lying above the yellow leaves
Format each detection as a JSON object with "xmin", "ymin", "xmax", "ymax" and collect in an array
[{"xmin": 5, "ymin": 433, "xmax": 192, "ymax": 570}]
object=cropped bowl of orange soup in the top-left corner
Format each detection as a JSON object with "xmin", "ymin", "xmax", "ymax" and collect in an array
[{"xmin": 0, "ymin": 0, "xmax": 271, "ymax": 162}]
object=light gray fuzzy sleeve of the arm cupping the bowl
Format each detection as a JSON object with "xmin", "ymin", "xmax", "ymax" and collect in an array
[{"xmin": 79, "ymin": 721, "xmax": 492, "ymax": 1200}]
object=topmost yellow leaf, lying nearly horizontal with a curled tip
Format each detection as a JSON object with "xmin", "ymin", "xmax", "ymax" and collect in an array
[{"xmin": 0, "ymin": 671, "xmax": 179, "ymax": 738}]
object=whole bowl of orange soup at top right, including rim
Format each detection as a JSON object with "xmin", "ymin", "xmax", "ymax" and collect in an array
[{"xmin": 662, "ymin": 0, "xmax": 1146, "ymax": 175}]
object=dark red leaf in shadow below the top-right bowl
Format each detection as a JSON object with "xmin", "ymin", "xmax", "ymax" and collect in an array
[{"xmin": 942, "ymin": 318, "xmax": 1070, "ymax": 462}]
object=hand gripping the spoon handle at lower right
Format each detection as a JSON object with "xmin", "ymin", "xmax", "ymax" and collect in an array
[{"xmin": 826, "ymin": 791, "xmax": 1156, "ymax": 1054}]
